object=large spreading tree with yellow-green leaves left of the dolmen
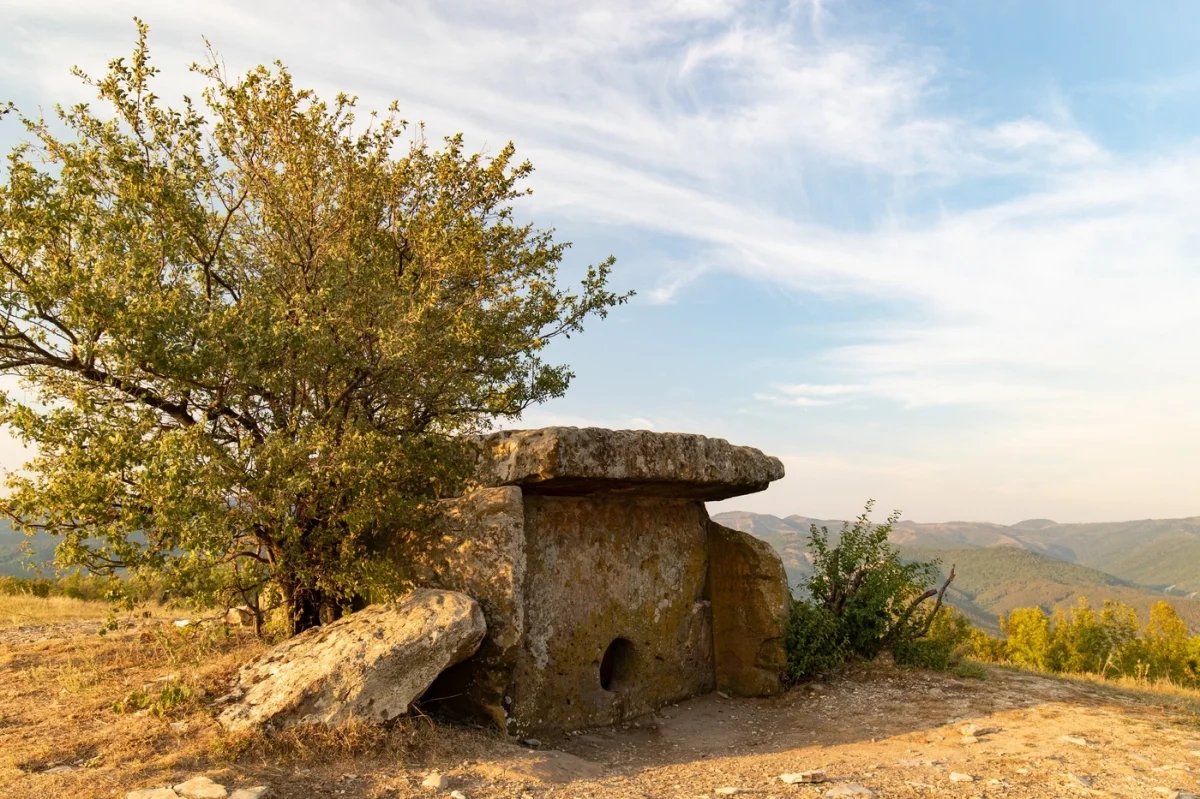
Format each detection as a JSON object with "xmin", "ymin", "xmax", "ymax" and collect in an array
[{"xmin": 0, "ymin": 20, "xmax": 629, "ymax": 631}]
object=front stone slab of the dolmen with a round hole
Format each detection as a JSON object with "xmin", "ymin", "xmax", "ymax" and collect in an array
[{"xmin": 509, "ymin": 495, "xmax": 714, "ymax": 733}]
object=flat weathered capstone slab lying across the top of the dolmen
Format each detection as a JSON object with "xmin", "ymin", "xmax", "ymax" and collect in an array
[{"xmin": 479, "ymin": 427, "xmax": 784, "ymax": 500}]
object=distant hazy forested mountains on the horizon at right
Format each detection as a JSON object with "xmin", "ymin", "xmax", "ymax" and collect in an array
[{"xmin": 713, "ymin": 511, "xmax": 1200, "ymax": 630}]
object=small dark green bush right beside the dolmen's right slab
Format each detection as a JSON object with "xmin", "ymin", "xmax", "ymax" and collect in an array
[{"xmin": 786, "ymin": 500, "xmax": 966, "ymax": 679}]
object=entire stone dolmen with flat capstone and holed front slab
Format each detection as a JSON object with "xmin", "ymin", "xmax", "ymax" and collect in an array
[{"xmin": 395, "ymin": 427, "xmax": 791, "ymax": 733}]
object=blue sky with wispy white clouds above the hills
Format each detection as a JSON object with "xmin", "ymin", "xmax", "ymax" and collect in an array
[{"xmin": 0, "ymin": 0, "xmax": 1200, "ymax": 523}]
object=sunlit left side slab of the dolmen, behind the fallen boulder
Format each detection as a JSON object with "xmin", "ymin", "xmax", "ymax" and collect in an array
[{"xmin": 403, "ymin": 486, "xmax": 526, "ymax": 729}]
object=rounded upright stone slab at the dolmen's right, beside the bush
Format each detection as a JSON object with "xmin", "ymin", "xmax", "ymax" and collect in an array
[{"xmin": 708, "ymin": 521, "xmax": 792, "ymax": 696}]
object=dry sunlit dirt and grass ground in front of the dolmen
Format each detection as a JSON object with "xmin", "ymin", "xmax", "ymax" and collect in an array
[{"xmin": 0, "ymin": 611, "xmax": 1200, "ymax": 799}]
